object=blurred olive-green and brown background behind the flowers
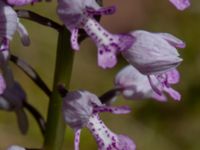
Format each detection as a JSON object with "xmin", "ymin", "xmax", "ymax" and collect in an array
[{"xmin": 0, "ymin": 0, "xmax": 200, "ymax": 150}]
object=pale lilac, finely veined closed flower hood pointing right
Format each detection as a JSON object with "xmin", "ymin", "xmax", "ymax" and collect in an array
[{"xmin": 122, "ymin": 30, "xmax": 185, "ymax": 75}]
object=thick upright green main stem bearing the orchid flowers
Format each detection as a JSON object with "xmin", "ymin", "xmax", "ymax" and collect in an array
[{"xmin": 44, "ymin": 26, "xmax": 74, "ymax": 150}]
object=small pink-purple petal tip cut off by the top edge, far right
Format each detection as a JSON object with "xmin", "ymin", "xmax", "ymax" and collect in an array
[{"xmin": 169, "ymin": 0, "xmax": 190, "ymax": 10}]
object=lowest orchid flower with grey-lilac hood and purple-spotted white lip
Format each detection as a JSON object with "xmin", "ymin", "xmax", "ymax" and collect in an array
[{"xmin": 63, "ymin": 91, "xmax": 136, "ymax": 150}]
